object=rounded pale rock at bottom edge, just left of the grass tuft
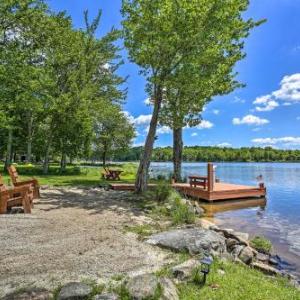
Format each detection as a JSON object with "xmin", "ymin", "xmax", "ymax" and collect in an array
[{"xmin": 127, "ymin": 274, "xmax": 159, "ymax": 300}]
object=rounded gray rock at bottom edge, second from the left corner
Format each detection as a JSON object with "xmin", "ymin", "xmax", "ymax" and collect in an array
[{"xmin": 57, "ymin": 282, "xmax": 92, "ymax": 300}]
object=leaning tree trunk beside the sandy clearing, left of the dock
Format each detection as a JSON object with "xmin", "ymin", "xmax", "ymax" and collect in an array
[{"xmin": 135, "ymin": 87, "xmax": 162, "ymax": 193}]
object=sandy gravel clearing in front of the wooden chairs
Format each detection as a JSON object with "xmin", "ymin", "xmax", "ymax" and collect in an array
[{"xmin": 0, "ymin": 188, "xmax": 168, "ymax": 297}]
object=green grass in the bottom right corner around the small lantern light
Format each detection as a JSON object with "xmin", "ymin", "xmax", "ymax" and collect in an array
[{"xmin": 178, "ymin": 261, "xmax": 300, "ymax": 300}]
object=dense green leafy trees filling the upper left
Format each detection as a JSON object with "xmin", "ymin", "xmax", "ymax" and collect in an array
[{"xmin": 0, "ymin": 0, "xmax": 133, "ymax": 173}]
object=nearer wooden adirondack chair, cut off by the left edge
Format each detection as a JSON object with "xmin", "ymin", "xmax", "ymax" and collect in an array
[{"xmin": 0, "ymin": 174, "xmax": 33, "ymax": 214}]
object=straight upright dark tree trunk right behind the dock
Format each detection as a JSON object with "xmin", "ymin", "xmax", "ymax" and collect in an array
[{"xmin": 173, "ymin": 128, "xmax": 183, "ymax": 182}]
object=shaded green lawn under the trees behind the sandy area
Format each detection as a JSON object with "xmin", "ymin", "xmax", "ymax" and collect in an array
[{"xmin": 0, "ymin": 163, "xmax": 137, "ymax": 186}]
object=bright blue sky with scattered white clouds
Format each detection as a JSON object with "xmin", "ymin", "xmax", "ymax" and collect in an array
[{"xmin": 48, "ymin": 0, "xmax": 300, "ymax": 149}]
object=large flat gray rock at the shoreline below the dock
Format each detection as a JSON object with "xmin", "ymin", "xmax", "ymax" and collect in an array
[{"xmin": 147, "ymin": 228, "xmax": 226, "ymax": 255}]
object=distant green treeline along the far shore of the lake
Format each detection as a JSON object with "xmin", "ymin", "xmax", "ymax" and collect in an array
[{"xmin": 114, "ymin": 146, "xmax": 300, "ymax": 162}]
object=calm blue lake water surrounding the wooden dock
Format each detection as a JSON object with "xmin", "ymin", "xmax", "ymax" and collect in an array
[{"xmin": 150, "ymin": 163, "xmax": 300, "ymax": 275}]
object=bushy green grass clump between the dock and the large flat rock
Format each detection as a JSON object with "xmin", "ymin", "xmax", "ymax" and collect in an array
[{"xmin": 171, "ymin": 198, "xmax": 196, "ymax": 225}]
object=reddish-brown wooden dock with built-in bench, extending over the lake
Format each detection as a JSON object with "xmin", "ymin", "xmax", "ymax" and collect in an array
[{"xmin": 110, "ymin": 163, "xmax": 266, "ymax": 202}]
